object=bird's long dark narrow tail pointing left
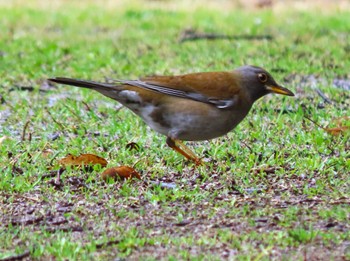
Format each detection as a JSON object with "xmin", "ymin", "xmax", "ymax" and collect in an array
[{"xmin": 48, "ymin": 77, "xmax": 118, "ymax": 91}]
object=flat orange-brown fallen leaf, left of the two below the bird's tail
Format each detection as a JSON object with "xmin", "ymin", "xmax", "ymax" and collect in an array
[{"xmin": 58, "ymin": 154, "xmax": 108, "ymax": 167}]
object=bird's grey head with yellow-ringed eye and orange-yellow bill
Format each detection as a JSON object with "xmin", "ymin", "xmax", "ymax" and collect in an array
[{"xmin": 235, "ymin": 65, "xmax": 294, "ymax": 102}]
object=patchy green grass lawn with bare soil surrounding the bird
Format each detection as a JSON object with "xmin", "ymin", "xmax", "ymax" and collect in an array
[{"xmin": 0, "ymin": 1, "xmax": 350, "ymax": 260}]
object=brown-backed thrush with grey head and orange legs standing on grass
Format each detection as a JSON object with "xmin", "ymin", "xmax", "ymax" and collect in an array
[{"xmin": 48, "ymin": 65, "xmax": 294, "ymax": 162}]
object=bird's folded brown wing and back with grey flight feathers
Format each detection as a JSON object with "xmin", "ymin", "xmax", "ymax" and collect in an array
[{"xmin": 117, "ymin": 72, "xmax": 239, "ymax": 109}]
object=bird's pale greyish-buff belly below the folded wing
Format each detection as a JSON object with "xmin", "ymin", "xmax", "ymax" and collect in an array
[{"xmin": 138, "ymin": 101, "xmax": 249, "ymax": 141}]
